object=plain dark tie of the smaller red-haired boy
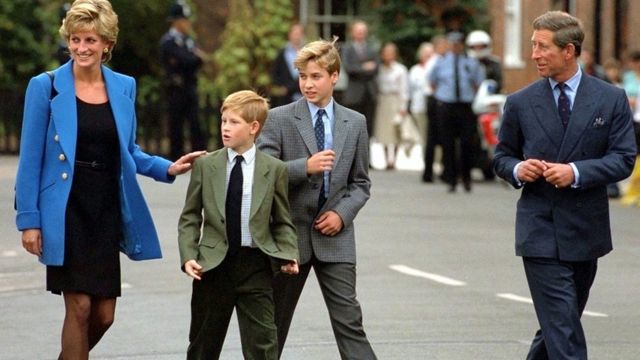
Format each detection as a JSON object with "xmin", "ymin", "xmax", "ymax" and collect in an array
[{"xmin": 225, "ymin": 155, "xmax": 244, "ymax": 255}]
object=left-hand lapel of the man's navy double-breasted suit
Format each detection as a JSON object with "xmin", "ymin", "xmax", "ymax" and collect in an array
[{"xmin": 531, "ymin": 78, "xmax": 564, "ymax": 149}]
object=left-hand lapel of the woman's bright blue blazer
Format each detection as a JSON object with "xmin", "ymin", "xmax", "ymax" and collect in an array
[{"xmin": 47, "ymin": 61, "xmax": 78, "ymax": 164}]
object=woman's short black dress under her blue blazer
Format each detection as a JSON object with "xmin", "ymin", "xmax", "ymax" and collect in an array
[{"xmin": 47, "ymin": 99, "xmax": 122, "ymax": 298}]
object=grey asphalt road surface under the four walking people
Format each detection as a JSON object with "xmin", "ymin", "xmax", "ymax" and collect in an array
[{"xmin": 0, "ymin": 156, "xmax": 640, "ymax": 360}]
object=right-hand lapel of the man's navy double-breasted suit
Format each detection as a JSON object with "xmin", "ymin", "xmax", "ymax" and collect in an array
[{"xmin": 558, "ymin": 73, "xmax": 597, "ymax": 161}]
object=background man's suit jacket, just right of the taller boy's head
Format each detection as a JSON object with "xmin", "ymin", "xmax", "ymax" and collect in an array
[{"xmin": 342, "ymin": 42, "xmax": 379, "ymax": 106}]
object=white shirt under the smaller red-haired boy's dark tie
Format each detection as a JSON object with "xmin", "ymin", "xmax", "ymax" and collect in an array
[{"xmin": 225, "ymin": 144, "xmax": 256, "ymax": 247}]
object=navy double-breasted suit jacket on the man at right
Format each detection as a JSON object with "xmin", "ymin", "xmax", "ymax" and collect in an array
[{"xmin": 494, "ymin": 73, "xmax": 636, "ymax": 261}]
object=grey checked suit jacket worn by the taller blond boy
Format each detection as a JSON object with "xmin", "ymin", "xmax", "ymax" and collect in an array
[{"xmin": 258, "ymin": 98, "xmax": 371, "ymax": 264}]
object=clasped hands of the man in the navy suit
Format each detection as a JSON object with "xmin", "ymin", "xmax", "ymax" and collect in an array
[{"xmin": 517, "ymin": 159, "xmax": 575, "ymax": 188}]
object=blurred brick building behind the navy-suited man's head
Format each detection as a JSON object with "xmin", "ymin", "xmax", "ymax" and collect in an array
[{"xmin": 489, "ymin": 0, "xmax": 640, "ymax": 92}]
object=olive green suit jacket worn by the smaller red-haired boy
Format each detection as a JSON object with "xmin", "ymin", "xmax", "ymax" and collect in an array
[{"xmin": 178, "ymin": 148, "xmax": 298, "ymax": 271}]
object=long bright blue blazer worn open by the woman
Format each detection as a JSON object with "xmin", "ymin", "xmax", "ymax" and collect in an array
[{"xmin": 16, "ymin": 61, "xmax": 174, "ymax": 265}]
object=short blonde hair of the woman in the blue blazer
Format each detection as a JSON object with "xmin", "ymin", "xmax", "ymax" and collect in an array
[{"xmin": 58, "ymin": 0, "xmax": 118, "ymax": 62}]
